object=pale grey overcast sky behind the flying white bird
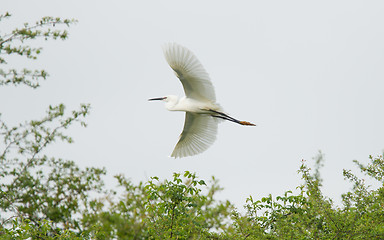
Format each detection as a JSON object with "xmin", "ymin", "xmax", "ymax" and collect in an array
[{"xmin": 0, "ymin": 0, "xmax": 384, "ymax": 208}]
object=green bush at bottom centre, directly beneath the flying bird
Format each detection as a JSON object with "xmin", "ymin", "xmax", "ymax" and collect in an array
[{"xmin": 79, "ymin": 171, "xmax": 233, "ymax": 239}]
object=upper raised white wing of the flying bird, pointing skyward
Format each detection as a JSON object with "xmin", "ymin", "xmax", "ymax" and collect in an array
[{"xmin": 163, "ymin": 43, "xmax": 216, "ymax": 102}]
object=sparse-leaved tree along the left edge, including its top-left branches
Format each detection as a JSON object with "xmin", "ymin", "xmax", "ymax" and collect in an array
[{"xmin": 0, "ymin": 13, "xmax": 105, "ymax": 236}]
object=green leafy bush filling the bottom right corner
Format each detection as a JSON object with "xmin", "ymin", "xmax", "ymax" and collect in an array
[{"xmin": 227, "ymin": 154, "xmax": 384, "ymax": 239}]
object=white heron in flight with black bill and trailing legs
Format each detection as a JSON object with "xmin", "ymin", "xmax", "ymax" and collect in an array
[{"xmin": 149, "ymin": 43, "xmax": 255, "ymax": 158}]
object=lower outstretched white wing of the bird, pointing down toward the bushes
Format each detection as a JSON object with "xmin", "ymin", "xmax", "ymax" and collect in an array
[{"xmin": 171, "ymin": 112, "xmax": 218, "ymax": 158}]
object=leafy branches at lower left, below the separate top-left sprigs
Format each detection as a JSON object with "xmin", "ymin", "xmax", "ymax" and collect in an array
[{"xmin": 0, "ymin": 105, "xmax": 105, "ymax": 234}]
